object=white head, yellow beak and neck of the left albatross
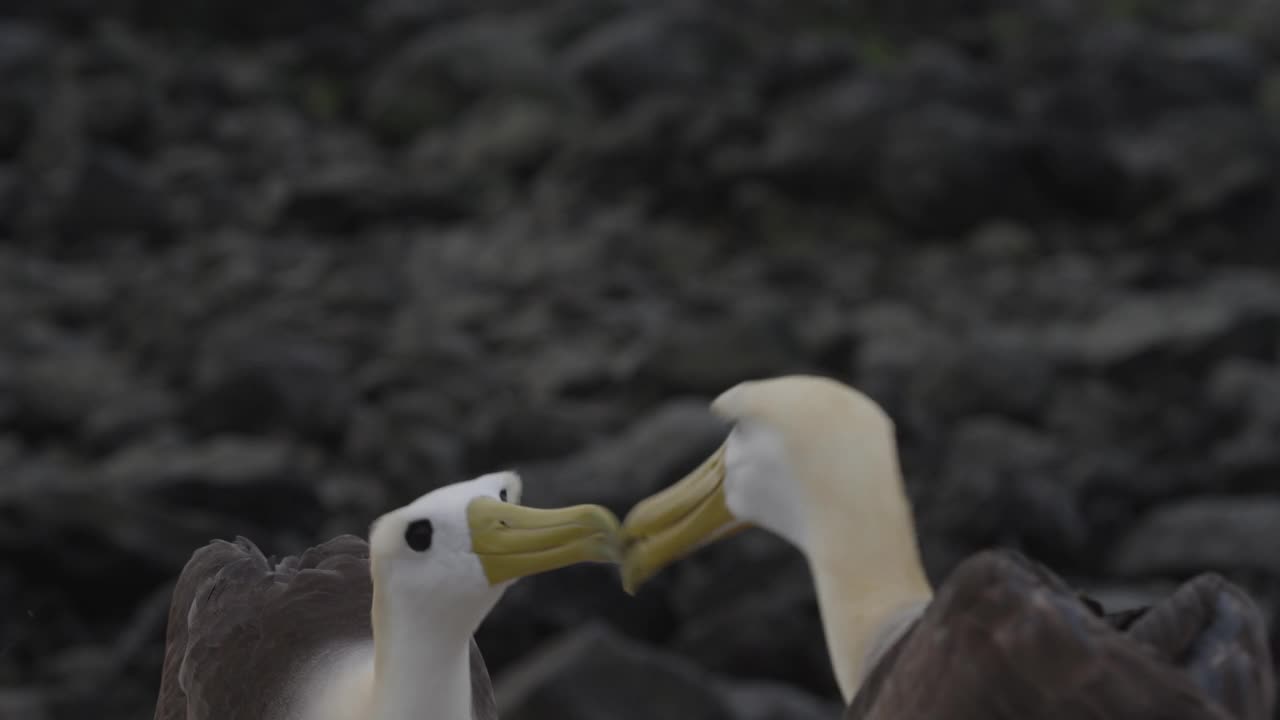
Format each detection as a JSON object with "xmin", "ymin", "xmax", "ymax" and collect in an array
[{"xmin": 348, "ymin": 471, "xmax": 621, "ymax": 720}]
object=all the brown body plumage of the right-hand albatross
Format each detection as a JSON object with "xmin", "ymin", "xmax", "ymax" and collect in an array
[{"xmin": 845, "ymin": 551, "xmax": 1276, "ymax": 720}]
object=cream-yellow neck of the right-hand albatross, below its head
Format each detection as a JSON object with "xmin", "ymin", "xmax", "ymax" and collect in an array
[{"xmin": 796, "ymin": 435, "xmax": 933, "ymax": 702}]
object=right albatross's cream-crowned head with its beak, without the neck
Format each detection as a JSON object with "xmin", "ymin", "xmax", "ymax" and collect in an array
[{"xmin": 623, "ymin": 375, "xmax": 902, "ymax": 589}]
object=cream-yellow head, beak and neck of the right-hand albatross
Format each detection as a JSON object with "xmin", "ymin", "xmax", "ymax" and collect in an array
[{"xmin": 622, "ymin": 375, "xmax": 931, "ymax": 697}]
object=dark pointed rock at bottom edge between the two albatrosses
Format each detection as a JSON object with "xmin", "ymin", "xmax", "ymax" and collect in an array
[{"xmin": 494, "ymin": 623, "xmax": 733, "ymax": 720}]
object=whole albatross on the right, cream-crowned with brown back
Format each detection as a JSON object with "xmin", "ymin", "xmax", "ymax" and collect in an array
[{"xmin": 622, "ymin": 375, "xmax": 1276, "ymax": 720}]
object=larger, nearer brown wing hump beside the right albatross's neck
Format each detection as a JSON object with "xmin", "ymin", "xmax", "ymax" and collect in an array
[{"xmin": 845, "ymin": 551, "xmax": 1264, "ymax": 720}]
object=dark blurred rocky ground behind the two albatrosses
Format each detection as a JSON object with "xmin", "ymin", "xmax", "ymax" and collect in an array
[{"xmin": 0, "ymin": 0, "xmax": 1280, "ymax": 720}]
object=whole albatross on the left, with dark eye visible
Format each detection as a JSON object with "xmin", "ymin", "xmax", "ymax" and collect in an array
[{"xmin": 155, "ymin": 471, "xmax": 620, "ymax": 720}]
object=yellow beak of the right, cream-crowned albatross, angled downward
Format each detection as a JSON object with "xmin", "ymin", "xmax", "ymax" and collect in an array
[{"xmin": 622, "ymin": 445, "xmax": 750, "ymax": 594}]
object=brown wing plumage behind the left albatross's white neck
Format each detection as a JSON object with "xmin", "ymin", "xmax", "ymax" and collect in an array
[{"xmin": 155, "ymin": 536, "xmax": 497, "ymax": 720}]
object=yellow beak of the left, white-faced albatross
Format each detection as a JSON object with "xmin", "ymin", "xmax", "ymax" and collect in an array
[{"xmin": 467, "ymin": 497, "xmax": 622, "ymax": 585}]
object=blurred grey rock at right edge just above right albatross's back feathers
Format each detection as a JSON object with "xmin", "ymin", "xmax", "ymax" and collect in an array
[{"xmin": 1108, "ymin": 496, "xmax": 1280, "ymax": 578}]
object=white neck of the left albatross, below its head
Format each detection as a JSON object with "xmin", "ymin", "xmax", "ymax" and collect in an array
[{"xmin": 371, "ymin": 589, "xmax": 471, "ymax": 720}]
